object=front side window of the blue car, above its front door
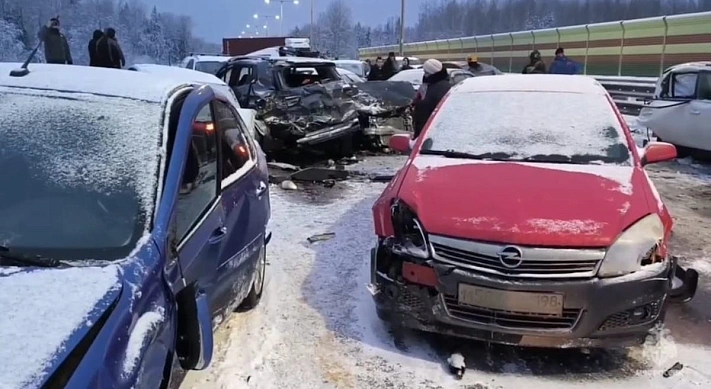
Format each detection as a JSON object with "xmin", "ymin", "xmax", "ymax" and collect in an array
[{"xmin": 176, "ymin": 101, "xmax": 217, "ymax": 240}]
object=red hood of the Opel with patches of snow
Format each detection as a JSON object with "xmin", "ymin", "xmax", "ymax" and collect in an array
[{"xmin": 398, "ymin": 156, "xmax": 649, "ymax": 247}]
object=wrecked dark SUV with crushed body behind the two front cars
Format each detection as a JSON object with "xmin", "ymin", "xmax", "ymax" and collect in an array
[{"xmin": 217, "ymin": 52, "xmax": 414, "ymax": 154}]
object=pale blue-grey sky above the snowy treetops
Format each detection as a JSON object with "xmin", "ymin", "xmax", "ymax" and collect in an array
[{"xmin": 143, "ymin": 0, "xmax": 425, "ymax": 43}]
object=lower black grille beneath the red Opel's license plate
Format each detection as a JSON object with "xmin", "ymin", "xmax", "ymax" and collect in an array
[{"xmin": 444, "ymin": 296, "xmax": 580, "ymax": 330}]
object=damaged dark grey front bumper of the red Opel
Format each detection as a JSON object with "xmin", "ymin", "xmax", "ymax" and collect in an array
[{"xmin": 370, "ymin": 241, "xmax": 675, "ymax": 348}]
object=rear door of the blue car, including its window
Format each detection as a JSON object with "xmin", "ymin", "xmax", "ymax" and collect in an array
[{"xmin": 213, "ymin": 100, "xmax": 268, "ymax": 310}]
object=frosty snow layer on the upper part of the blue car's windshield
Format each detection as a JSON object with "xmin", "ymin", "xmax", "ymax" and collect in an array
[{"xmin": 0, "ymin": 88, "xmax": 162, "ymax": 240}]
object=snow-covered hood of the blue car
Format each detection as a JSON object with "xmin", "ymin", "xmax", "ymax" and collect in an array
[{"xmin": 0, "ymin": 265, "xmax": 121, "ymax": 388}]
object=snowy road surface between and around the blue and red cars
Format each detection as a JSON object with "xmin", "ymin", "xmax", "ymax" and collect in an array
[{"xmin": 183, "ymin": 116, "xmax": 711, "ymax": 389}]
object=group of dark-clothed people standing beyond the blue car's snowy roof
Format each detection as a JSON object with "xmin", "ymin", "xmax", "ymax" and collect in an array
[{"xmin": 38, "ymin": 17, "xmax": 126, "ymax": 69}]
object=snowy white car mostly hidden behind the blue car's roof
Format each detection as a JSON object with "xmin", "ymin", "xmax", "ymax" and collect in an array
[{"xmin": 128, "ymin": 64, "xmax": 262, "ymax": 139}]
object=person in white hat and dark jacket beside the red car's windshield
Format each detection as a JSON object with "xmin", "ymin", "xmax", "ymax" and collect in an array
[{"xmin": 413, "ymin": 59, "xmax": 452, "ymax": 138}]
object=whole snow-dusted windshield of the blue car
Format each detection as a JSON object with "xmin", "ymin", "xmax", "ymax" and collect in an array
[{"xmin": 0, "ymin": 87, "xmax": 162, "ymax": 260}]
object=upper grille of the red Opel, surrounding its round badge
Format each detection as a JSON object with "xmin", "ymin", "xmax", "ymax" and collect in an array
[{"xmin": 432, "ymin": 243, "xmax": 600, "ymax": 276}]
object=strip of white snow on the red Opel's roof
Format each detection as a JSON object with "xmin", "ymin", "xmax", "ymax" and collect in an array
[{"xmin": 452, "ymin": 74, "xmax": 606, "ymax": 95}]
